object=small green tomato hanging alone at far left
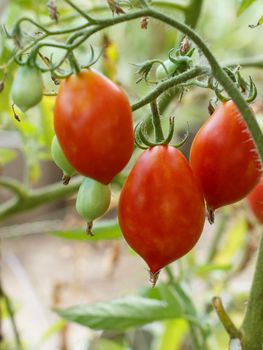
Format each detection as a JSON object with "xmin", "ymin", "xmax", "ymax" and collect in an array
[{"xmin": 11, "ymin": 65, "xmax": 43, "ymax": 112}]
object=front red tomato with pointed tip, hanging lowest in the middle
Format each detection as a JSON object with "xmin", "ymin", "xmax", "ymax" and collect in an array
[{"xmin": 118, "ymin": 146, "xmax": 205, "ymax": 274}]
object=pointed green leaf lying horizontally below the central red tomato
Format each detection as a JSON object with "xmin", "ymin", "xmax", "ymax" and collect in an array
[{"xmin": 55, "ymin": 296, "xmax": 182, "ymax": 331}]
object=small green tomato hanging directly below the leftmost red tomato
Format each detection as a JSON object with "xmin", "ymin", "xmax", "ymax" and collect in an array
[{"xmin": 76, "ymin": 177, "xmax": 111, "ymax": 234}]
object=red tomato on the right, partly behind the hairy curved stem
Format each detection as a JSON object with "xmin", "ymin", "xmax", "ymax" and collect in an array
[{"xmin": 190, "ymin": 101, "xmax": 261, "ymax": 210}]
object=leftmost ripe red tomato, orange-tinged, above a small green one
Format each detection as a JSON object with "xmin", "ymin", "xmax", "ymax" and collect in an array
[{"xmin": 54, "ymin": 70, "xmax": 134, "ymax": 184}]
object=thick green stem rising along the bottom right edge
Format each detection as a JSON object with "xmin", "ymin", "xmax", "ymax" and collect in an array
[{"xmin": 241, "ymin": 230, "xmax": 263, "ymax": 350}]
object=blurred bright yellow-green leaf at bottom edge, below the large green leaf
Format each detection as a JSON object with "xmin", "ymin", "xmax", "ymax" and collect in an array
[{"xmin": 158, "ymin": 319, "xmax": 189, "ymax": 350}]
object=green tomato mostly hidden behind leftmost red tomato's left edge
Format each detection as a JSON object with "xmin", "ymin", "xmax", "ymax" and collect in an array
[{"xmin": 51, "ymin": 136, "xmax": 76, "ymax": 185}]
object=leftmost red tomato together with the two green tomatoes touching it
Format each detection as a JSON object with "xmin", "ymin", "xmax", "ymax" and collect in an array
[{"xmin": 51, "ymin": 70, "xmax": 134, "ymax": 234}]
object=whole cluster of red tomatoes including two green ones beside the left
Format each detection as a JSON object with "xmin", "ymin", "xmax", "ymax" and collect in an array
[{"xmin": 49, "ymin": 70, "xmax": 262, "ymax": 284}]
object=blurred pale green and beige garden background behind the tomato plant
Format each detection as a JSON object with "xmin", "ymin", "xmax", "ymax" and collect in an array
[{"xmin": 0, "ymin": 0, "xmax": 263, "ymax": 350}]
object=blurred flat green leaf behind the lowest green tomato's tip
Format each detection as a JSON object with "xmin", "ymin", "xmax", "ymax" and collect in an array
[{"xmin": 51, "ymin": 220, "xmax": 121, "ymax": 242}]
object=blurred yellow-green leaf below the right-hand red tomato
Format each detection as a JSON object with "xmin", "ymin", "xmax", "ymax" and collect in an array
[{"xmin": 215, "ymin": 217, "xmax": 247, "ymax": 264}]
